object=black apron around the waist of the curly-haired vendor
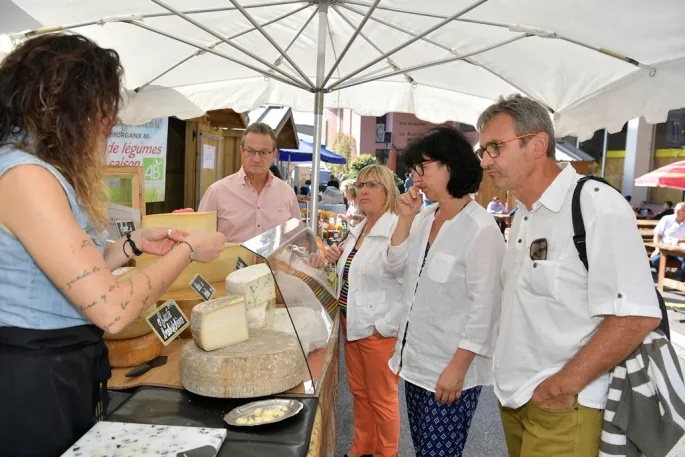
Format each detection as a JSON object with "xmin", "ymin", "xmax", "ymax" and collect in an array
[{"xmin": 0, "ymin": 325, "xmax": 112, "ymax": 457}]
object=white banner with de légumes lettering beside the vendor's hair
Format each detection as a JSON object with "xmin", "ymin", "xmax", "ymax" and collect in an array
[{"xmin": 107, "ymin": 117, "xmax": 169, "ymax": 203}]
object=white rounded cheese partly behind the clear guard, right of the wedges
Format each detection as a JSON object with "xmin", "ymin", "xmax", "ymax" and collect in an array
[{"xmin": 271, "ymin": 307, "xmax": 330, "ymax": 354}]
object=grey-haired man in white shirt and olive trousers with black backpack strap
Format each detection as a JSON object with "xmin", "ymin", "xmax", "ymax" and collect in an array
[{"xmin": 477, "ymin": 95, "xmax": 661, "ymax": 457}]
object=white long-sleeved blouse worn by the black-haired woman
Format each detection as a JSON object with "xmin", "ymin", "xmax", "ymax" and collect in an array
[{"xmin": 388, "ymin": 202, "xmax": 505, "ymax": 392}]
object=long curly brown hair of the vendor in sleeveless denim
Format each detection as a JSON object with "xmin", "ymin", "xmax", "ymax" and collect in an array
[{"xmin": 0, "ymin": 34, "xmax": 123, "ymax": 227}]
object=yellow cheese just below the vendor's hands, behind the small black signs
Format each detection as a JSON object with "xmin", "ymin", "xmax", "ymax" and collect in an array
[{"xmin": 134, "ymin": 243, "xmax": 248, "ymax": 292}]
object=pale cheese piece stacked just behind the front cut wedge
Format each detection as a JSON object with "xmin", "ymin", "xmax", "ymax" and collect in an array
[{"xmin": 226, "ymin": 263, "xmax": 276, "ymax": 309}]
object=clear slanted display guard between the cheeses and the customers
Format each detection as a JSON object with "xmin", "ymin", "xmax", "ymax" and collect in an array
[{"xmin": 242, "ymin": 219, "xmax": 338, "ymax": 394}]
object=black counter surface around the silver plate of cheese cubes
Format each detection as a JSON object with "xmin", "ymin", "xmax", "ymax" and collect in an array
[{"xmin": 106, "ymin": 387, "xmax": 319, "ymax": 457}]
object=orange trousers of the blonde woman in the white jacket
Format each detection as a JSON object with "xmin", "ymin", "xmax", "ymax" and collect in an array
[{"xmin": 341, "ymin": 316, "xmax": 400, "ymax": 457}]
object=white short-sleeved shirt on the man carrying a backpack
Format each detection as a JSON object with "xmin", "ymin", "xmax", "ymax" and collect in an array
[{"xmin": 494, "ymin": 164, "xmax": 661, "ymax": 409}]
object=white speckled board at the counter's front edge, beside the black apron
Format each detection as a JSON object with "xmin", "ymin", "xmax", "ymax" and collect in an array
[{"xmin": 62, "ymin": 421, "xmax": 226, "ymax": 457}]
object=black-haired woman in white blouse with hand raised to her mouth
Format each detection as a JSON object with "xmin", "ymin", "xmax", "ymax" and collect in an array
[{"xmin": 388, "ymin": 127, "xmax": 505, "ymax": 457}]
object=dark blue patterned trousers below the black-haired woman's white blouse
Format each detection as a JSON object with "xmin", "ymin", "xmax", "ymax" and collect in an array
[{"xmin": 405, "ymin": 382, "xmax": 482, "ymax": 457}]
